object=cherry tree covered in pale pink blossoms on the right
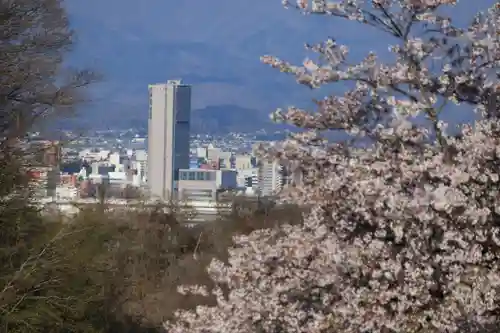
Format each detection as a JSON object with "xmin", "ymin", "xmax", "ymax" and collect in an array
[{"xmin": 165, "ymin": 0, "xmax": 500, "ymax": 333}]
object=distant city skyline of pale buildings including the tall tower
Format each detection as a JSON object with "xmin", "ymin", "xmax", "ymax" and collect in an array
[{"xmin": 31, "ymin": 79, "xmax": 292, "ymax": 222}]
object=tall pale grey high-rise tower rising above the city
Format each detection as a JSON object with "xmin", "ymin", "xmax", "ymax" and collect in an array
[{"xmin": 148, "ymin": 80, "xmax": 191, "ymax": 200}]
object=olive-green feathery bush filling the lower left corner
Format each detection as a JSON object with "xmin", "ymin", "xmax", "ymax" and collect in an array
[{"xmin": 0, "ymin": 201, "xmax": 164, "ymax": 333}]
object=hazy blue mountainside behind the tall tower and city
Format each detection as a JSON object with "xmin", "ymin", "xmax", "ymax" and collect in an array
[{"xmin": 62, "ymin": 0, "xmax": 495, "ymax": 127}]
